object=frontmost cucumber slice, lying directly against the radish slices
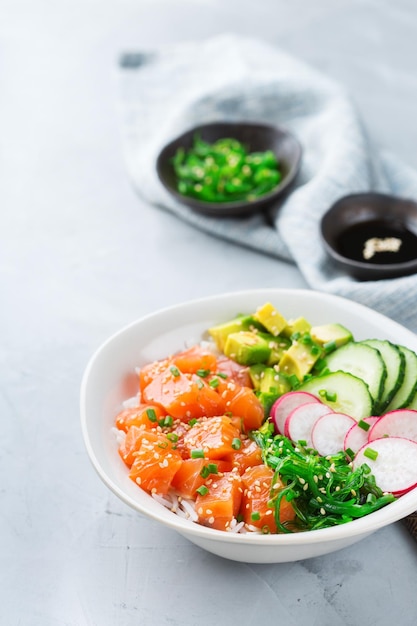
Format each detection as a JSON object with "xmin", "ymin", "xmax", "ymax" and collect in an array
[{"xmin": 297, "ymin": 372, "xmax": 373, "ymax": 421}]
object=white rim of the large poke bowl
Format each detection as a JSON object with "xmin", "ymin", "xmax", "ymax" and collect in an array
[{"xmin": 80, "ymin": 288, "xmax": 417, "ymax": 547}]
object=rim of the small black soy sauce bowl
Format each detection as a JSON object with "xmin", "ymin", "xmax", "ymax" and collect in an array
[{"xmin": 320, "ymin": 191, "xmax": 417, "ymax": 275}]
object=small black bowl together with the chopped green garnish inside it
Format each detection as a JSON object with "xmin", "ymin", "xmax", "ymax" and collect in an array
[{"xmin": 156, "ymin": 122, "xmax": 301, "ymax": 217}]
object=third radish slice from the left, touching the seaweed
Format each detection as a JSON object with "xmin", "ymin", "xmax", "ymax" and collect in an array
[{"xmin": 311, "ymin": 412, "xmax": 357, "ymax": 456}]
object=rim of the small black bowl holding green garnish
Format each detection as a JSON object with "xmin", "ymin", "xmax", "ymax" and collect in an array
[{"xmin": 155, "ymin": 120, "xmax": 303, "ymax": 215}]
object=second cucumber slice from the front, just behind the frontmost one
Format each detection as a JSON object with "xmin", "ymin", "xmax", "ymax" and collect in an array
[{"xmin": 326, "ymin": 341, "xmax": 387, "ymax": 407}]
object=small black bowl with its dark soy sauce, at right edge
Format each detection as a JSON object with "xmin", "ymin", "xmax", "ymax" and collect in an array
[{"xmin": 321, "ymin": 193, "xmax": 417, "ymax": 280}]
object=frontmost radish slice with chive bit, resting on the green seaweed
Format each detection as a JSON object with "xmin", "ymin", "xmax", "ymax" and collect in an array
[{"xmin": 353, "ymin": 437, "xmax": 417, "ymax": 496}]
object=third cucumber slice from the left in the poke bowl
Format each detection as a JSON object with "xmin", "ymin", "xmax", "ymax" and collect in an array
[{"xmin": 361, "ymin": 339, "xmax": 405, "ymax": 414}]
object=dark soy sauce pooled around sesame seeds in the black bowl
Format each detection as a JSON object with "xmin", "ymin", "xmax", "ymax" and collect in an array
[{"xmin": 336, "ymin": 220, "xmax": 417, "ymax": 265}]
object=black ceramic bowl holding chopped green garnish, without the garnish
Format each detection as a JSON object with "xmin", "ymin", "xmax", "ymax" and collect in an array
[{"xmin": 156, "ymin": 122, "xmax": 302, "ymax": 217}]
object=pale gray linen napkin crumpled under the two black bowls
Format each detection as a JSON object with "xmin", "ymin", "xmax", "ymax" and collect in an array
[{"xmin": 120, "ymin": 35, "xmax": 417, "ymax": 331}]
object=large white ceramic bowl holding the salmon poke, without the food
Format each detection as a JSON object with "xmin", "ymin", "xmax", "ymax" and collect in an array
[{"xmin": 81, "ymin": 289, "xmax": 417, "ymax": 563}]
